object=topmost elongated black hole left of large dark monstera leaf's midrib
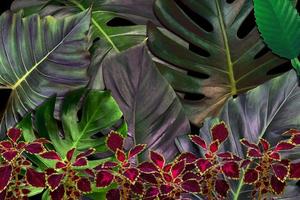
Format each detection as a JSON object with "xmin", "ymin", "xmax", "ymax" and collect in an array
[{"xmin": 175, "ymin": 0, "xmax": 214, "ymax": 32}]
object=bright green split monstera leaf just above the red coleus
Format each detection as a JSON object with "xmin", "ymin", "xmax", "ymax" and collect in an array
[{"xmin": 19, "ymin": 89, "xmax": 127, "ymax": 160}]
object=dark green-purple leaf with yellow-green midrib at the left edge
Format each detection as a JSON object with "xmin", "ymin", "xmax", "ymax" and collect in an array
[{"xmin": 0, "ymin": 11, "xmax": 90, "ymax": 137}]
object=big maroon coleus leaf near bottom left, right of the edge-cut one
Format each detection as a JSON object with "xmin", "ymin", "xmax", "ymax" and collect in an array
[{"xmin": 25, "ymin": 168, "xmax": 46, "ymax": 187}]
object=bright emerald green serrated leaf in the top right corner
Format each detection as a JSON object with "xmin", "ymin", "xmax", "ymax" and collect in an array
[{"xmin": 254, "ymin": 0, "xmax": 300, "ymax": 59}]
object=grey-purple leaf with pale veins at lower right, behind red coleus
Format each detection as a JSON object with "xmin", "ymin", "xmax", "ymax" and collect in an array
[{"xmin": 177, "ymin": 71, "xmax": 300, "ymax": 200}]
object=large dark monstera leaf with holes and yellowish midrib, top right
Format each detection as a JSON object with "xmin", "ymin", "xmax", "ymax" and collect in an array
[{"xmin": 148, "ymin": 0, "xmax": 289, "ymax": 125}]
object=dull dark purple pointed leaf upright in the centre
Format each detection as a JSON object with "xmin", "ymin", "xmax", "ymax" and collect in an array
[{"xmin": 102, "ymin": 46, "xmax": 190, "ymax": 160}]
